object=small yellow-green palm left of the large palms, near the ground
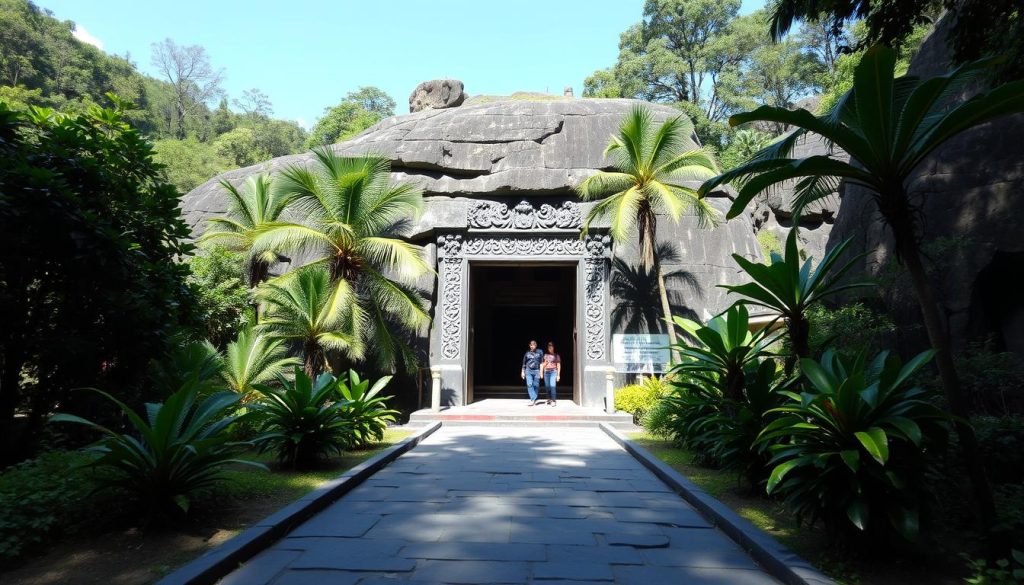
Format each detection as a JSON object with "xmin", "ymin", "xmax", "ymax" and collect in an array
[{"xmin": 220, "ymin": 327, "xmax": 302, "ymax": 400}]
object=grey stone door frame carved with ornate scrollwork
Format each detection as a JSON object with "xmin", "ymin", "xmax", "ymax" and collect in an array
[{"xmin": 430, "ymin": 201, "xmax": 611, "ymax": 407}]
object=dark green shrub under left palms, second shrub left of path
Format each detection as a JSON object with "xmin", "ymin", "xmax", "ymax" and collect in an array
[{"xmin": 248, "ymin": 367, "xmax": 352, "ymax": 467}]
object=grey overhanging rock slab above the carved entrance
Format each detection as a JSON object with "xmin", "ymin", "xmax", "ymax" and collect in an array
[{"xmin": 182, "ymin": 97, "xmax": 696, "ymax": 235}]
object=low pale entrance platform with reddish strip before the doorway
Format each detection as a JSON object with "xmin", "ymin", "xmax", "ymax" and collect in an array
[{"xmin": 409, "ymin": 398, "xmax": 637, "ymax": 430}]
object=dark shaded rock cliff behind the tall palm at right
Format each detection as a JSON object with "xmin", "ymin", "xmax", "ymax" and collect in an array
[{"xmin": 829, "ymin": 19, "xmax": 1024, "ymax": 354}]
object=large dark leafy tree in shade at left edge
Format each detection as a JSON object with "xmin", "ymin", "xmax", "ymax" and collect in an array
[{"xmin": 0, "ymin": 102, "xmax": 195, "ymax": 464}]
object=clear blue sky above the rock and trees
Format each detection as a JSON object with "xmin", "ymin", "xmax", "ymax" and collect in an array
[{"xmin": 36, "ymin": 0, "xmax": 763, "ymax": 126}]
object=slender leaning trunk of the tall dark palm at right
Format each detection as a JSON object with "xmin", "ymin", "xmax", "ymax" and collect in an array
[{"xmin": 886, "ymin": 193, "xmax": 995, "ymax": 532}]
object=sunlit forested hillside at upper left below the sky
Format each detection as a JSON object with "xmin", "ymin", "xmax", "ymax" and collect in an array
[{"xmin": 0, "ymin": 0, "xmax": 394, "ymax": 193}]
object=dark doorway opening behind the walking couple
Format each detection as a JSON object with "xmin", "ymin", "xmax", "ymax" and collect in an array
[{"xmin": 469, "ymin": 264, "xmax": 578, "ymax": 402}]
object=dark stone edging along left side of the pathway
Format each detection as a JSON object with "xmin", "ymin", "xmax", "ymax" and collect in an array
[{"xmin": 157, "ymin": 421, "xmax": 441, "ymax": 585}]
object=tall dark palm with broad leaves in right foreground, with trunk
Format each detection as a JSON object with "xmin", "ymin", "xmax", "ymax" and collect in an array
[{"xmin": 700, "ymin": 46, "xmax": 1024, "ymax": 526}]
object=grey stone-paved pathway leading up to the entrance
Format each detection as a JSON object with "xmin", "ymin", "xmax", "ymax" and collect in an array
[{"xmin": 221, "ymin": 426, "xmax": 777, "ymax": 585}]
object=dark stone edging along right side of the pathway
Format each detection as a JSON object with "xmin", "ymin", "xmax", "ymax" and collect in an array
[{"xmin": 600, "ymin": 423, "xmax": 836, "ymax": 585}]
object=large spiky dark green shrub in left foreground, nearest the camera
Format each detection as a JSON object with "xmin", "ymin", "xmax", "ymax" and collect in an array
[{"xmin": 51, "ymin": 379, "xmax": 263, "ymax": 520}]
